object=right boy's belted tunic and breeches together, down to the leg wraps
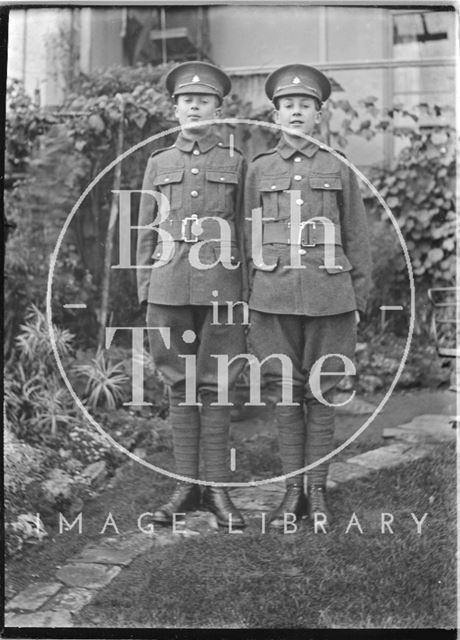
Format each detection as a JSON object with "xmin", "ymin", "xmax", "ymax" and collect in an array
[{"xmin": 245, "ymin": 137, "xmax": 371, "ymax": 402}]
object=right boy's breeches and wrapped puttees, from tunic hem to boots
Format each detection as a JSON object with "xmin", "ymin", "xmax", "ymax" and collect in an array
[{"xmin": 249, "ymin": 311, "xmax": 356, "ymax": 485}]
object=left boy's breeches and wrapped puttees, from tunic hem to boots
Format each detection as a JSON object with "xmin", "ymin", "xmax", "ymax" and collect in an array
[{"xmin": 147, "ymin": 304, "xmax": 245, "ymax": 482}]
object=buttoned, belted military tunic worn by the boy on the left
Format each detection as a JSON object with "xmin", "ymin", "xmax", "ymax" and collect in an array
[{"xmin": 136, "ymin": 129, "xmax": 246, "ymax": 306}]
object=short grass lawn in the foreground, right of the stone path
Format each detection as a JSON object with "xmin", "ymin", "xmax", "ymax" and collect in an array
[{"xmin": 76, "ymin": 445, "xmax": 456, "ymax": 628}]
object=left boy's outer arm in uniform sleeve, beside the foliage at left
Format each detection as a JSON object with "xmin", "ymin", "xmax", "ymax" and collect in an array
[{"xmin": 136, "ymin": 158, "xmax": 157, "ymax": 304}]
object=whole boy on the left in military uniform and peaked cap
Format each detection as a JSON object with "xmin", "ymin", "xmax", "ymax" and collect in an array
[{"xmin": 137, "ymin": 62, "xmax": 245, "ymax": 528}]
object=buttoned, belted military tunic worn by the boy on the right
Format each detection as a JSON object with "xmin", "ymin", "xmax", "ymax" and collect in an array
[{"xmin": 246, "ymin": 138, "xmax": 370, "ymax": 316}]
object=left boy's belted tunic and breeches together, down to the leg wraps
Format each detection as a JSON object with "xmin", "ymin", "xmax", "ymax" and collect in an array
[{"xmin": 136, "ymin": 128, "xmax": 247, "ymax": 402}]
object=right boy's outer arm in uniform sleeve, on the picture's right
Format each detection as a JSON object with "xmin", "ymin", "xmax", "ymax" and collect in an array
[{"xmin": 341, "ymin": 165, "xmax": 372, "ymax": 312}]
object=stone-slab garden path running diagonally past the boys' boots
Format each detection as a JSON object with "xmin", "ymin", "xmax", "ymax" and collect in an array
[{"xmin": 5, "ymin": 392, "xmax": 456, "ymax": 628}]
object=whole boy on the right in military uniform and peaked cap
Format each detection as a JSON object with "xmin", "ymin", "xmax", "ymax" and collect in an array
[{"xmin": 245, "ymin": 64, "xmax": 370, "ymax": 529}]
